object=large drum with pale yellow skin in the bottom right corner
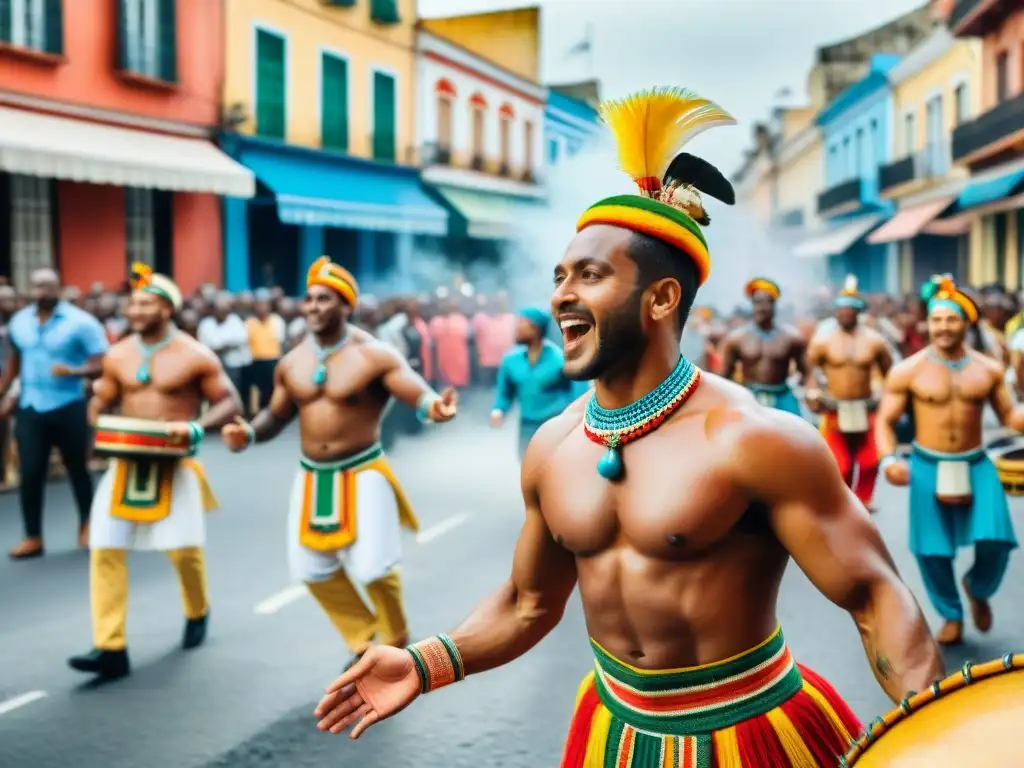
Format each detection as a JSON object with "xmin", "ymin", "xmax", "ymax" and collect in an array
[{"xmin": 840, "ymin": 653, "xmax": 1024, "ymax": 768}]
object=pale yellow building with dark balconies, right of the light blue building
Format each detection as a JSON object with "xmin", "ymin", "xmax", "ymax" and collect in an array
[{"xmin": 868, "ymin": 28, "xmax": 981, "ymax": 292}]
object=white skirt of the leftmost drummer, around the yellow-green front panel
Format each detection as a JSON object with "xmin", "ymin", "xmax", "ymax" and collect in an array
[{"xmin": 89, "ymin": 460, "xmax": 206, "ymax": 551}]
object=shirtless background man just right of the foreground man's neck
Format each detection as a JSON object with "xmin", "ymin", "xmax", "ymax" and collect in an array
[{"xmin": 723, "ymin": 278, "xmax": 806, "ymax": 416}]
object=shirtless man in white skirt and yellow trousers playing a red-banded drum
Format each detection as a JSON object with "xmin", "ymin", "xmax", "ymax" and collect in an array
[{"xmin": 69, "ymin": 264, "xmax": 242, "ymax": 679}]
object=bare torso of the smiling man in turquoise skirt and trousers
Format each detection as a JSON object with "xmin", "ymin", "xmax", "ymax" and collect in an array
[{"xmin": 900, "ymin": 347, "xmax": 1002, "ymax": 454}]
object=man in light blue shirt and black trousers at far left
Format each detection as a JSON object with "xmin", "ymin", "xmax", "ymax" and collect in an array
[{"xmin": 0, "ymin": 269, "xmax": 108, "ymax": 560}]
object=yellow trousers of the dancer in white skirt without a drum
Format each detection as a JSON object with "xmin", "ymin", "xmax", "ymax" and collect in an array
[{"xmin": 306, "ymin": 568, "xmax": 409, "ymax": 653}]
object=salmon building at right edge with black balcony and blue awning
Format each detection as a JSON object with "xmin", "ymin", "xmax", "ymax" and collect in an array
[{"xmin": 943, "ymin": 0, "xmax": 1024, "ymax": 288}]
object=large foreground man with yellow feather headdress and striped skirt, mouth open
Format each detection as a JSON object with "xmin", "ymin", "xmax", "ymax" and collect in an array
[{"xmin": 315, "ymin": 89, "xmax": 943, "ymax": 768}]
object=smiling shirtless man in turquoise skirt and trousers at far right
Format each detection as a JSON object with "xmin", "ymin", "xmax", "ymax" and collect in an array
[{"xmin": 876, "ymin": 276, "xmax": 1024, "ymax": 645}]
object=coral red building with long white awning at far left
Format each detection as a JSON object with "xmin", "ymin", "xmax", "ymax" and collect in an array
[{"xmin": 0, "ymin": 0, "xmax": 254, "ymax": 292}]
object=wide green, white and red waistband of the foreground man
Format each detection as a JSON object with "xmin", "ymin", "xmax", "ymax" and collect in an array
[{"xmin": 591, "ymin": 627, "xmax": 803, "ymax": 735}]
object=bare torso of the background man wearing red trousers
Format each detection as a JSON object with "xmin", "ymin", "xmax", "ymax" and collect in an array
[{"xmin": 807, "ymin": 326, "xmax": 888, "ymax": 400}]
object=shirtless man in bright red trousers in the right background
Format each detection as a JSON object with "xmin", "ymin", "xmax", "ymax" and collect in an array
[{"xmin": 806, "ymin": 278, "xmax": 892, "ymax": 510}]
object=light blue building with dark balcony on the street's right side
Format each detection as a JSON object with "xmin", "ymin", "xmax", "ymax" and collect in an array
[{"xmin": 795, "ymin": 54, "xmax": 899, "ymax": 293}]
